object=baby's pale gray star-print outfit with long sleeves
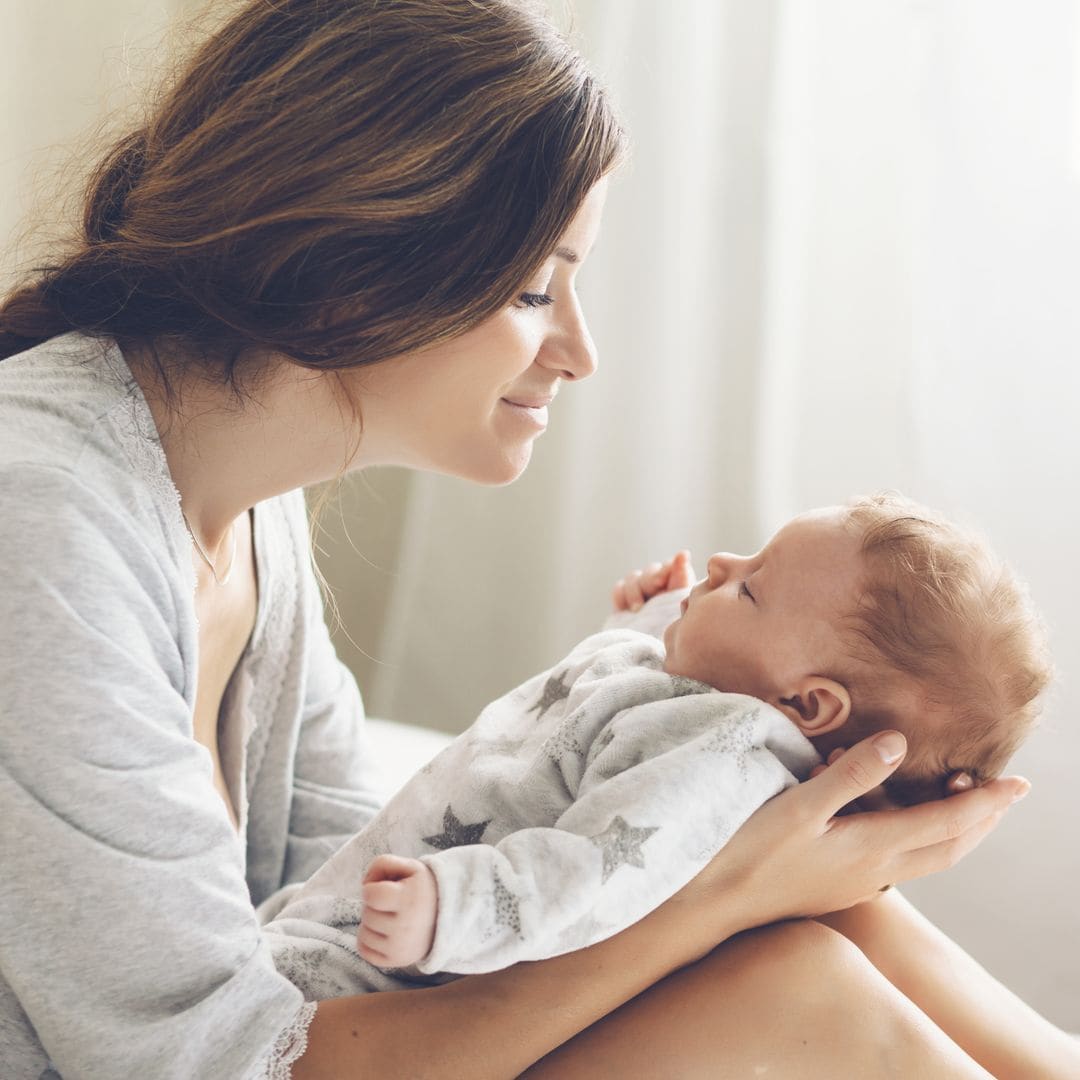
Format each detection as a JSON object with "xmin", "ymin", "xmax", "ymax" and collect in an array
[{"xmin": 265, "ymin": 591, "xmax": 820, "ymax": 1000}]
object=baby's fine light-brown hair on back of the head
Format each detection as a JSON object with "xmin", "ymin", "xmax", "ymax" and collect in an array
[{"xmin": 837, "ymin": 492, "xmax": 1053, "ymax": 804}]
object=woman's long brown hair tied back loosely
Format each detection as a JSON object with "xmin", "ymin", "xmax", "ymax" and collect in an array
[{"xmin": 0, "ymin": 0, "xmax": 623, "ymax": 384}]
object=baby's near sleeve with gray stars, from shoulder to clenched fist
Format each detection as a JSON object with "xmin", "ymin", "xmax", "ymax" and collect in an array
[{"xmin": 419, "ymin": 670, "xmax": 818, "ymax": 974}]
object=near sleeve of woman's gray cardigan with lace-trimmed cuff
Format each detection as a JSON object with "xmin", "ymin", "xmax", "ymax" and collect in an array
[{"xmin": 0, "ymin": 465, "xmax": 311, "ymax": 1080}]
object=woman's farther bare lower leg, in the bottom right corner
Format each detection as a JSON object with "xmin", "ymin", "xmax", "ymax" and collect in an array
[{"xmin": 821, "ymin": 890, "xmax": 1080, "ymax": 1080}]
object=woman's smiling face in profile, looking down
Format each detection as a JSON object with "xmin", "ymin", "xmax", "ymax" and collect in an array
[{"xmin": 352, "ymin": 178, "xmax": 607, "ymax": 484}]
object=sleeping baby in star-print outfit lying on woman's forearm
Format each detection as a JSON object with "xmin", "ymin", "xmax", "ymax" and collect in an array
[{"xmin": 266, "ymin": 496, "xmax": 1050, "ymax": 999}]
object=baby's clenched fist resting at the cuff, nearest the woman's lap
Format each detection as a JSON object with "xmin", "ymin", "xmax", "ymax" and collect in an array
[{"xmin": 356, "ymin": 855, "xmax": 438, "ymax": 968}]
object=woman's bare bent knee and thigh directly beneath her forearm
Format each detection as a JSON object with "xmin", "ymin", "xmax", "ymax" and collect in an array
[{"xmin": 525, "ymin": 921, "xmax": 989, "ymax": 1080}]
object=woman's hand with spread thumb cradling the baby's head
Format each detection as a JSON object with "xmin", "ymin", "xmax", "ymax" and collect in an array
[{"xmin": 677, "ymin": 731, "xmax": 1030, "ymax": 933}]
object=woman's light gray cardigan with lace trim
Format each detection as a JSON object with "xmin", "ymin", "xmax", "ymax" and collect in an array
[{"xmin": 0, "ymin": 334, "xmax": 379, "ymax": 1080}]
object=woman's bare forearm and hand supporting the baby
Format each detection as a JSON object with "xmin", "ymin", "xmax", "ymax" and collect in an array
[{"xmin": 293, "ymin": 735, "xmax": 1026, "ymax": 1080}]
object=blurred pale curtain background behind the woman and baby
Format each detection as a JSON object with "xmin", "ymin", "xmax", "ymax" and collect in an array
[{"xmin": 0, "ymin": 0, "xmax": 1080, "ymax": 1029}]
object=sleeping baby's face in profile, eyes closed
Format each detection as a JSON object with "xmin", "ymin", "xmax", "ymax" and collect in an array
[{"xmin": 664, "ymin": 508, "xmax": 861, "ymax": 703}]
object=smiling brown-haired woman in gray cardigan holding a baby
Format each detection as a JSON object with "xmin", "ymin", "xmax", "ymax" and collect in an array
[{"xmin": 0, "ymin": 0, "xmax": 1062, "ymax": 1078}]
